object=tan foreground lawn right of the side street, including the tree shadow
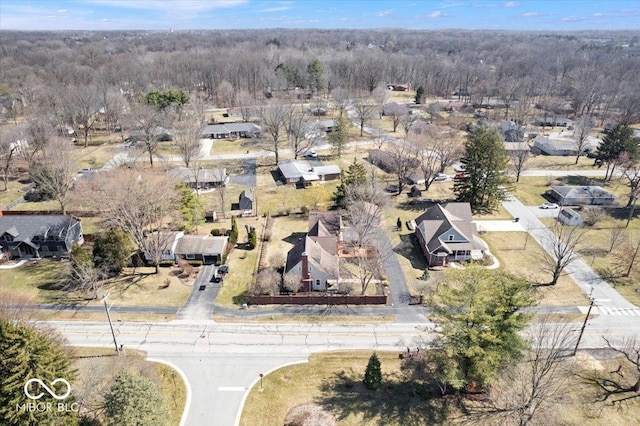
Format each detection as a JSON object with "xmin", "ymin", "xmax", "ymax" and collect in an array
[{"xmin": 240, "ymin": 352, "xmax": 640, "ymax": 426}]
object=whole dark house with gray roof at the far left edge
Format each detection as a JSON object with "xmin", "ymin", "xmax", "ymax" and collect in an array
[{"xmin": 0, "ymin": 213, "xmax": 84, "ymax": 259}]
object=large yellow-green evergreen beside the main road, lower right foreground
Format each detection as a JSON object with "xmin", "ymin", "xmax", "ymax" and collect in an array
[{"xmin": 434, "ymin": 266, "xmax": 535, "ymax": 389}]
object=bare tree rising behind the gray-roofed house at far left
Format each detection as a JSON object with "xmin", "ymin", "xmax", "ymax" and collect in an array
[{"xmin": 29, "ymin": 138, "xmax": 78, "ymax": 214}]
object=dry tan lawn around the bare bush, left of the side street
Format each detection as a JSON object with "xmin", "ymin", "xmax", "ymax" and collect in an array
[{"xmin": 72, "ymin": 347, "xmax": 187, "ymax": 425}]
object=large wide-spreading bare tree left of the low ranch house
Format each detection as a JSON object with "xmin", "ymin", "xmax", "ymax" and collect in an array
[{"xmin": 79, "ymin": 169, "xmax": 179, "ymax": 273}]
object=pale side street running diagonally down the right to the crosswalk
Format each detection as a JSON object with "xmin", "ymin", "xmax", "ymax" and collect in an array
[{"xmin": 503, "ymin": 198, "xmax": 640, "ymax": 316}]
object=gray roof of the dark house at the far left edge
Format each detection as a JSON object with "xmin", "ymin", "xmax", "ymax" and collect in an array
[{"xmin": 0, "ymin": 214, "xmax": 82, "ymax": 245}]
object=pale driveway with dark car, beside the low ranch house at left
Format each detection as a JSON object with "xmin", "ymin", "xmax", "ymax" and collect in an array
[{"xmin": 177, "ymin": 265, "xmax": 222, "ymax": 321}]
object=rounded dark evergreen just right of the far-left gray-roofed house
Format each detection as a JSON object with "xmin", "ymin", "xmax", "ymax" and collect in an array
[{"xmin": 93, "ymin": 228, "xmax": 136, "ymax": 276}]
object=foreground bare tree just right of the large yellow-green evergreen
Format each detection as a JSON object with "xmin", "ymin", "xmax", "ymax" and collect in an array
[{"xmin": 471, "ymin": 317, "xmax": 575, "ymax": 426}]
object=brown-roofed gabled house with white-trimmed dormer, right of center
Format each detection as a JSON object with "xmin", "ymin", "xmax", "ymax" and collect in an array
[{"xmin": 412, "ymin": 203, "xmax": 488, "ymax": 266}]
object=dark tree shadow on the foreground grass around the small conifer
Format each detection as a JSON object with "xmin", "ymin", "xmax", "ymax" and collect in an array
[{"xmin": 314, "ymin": 371, "xmax": 463, "ymax": 426}]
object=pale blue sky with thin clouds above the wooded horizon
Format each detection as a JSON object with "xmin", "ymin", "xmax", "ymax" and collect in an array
[{"xmin": 0, "ymin": 0, "xmax": 640, "ymax": 31}]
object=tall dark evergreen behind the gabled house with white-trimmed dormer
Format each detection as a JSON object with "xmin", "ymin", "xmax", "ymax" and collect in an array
[{"xmin": 453, "ymin": 127, "xmax": 511, "ymax": 213}]
